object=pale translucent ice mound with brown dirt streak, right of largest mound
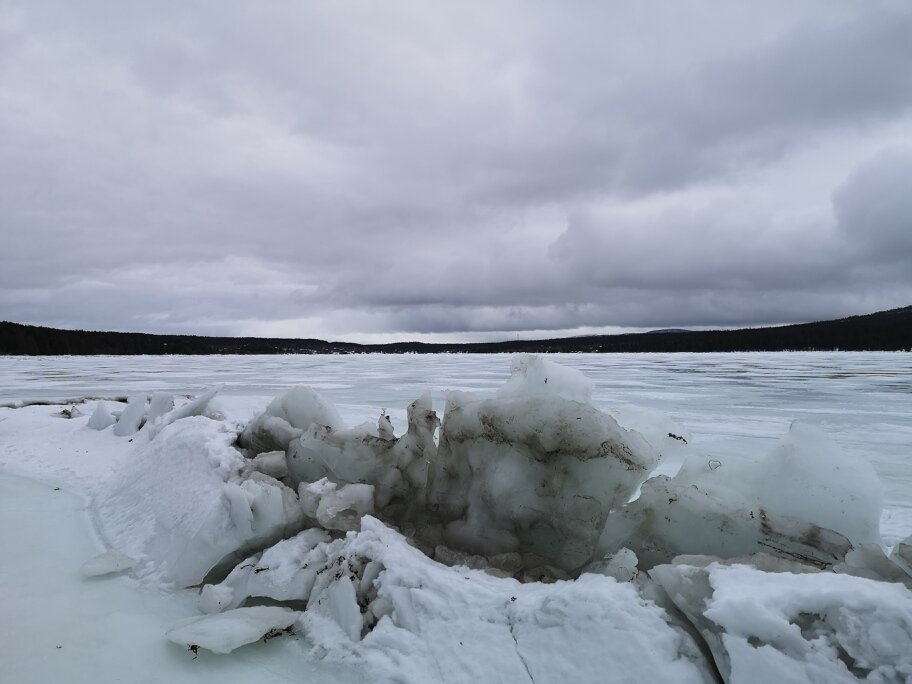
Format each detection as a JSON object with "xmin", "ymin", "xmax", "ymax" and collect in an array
[{"xmin": 599, "ymin": 424, "xmax": 882, "ymax": 569}]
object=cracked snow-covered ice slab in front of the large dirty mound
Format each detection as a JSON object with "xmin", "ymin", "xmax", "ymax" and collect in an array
[{"xmin": 198, "ymin": 517, "xmax": 712, "ymax": 684}]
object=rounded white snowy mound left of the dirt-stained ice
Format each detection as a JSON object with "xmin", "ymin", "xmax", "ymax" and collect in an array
[{"xmin": 96, "ymin": 416, "xmax": 304, "ymax": 586}]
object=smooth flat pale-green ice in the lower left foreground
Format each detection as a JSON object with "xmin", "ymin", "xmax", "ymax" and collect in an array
[{"xmin": 0, "ymin": 472, "xmax": 366, "ymax": 684}]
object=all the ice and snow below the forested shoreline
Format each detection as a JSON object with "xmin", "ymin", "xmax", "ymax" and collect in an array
[{"xmin": 0, "ymin": 353, "xmax": 912, "ymax": 684}]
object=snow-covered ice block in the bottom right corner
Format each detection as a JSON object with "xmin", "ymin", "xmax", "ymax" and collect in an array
[{"xmin": 650, "ymin": 563, "xmax": 912, "ymax": 682}]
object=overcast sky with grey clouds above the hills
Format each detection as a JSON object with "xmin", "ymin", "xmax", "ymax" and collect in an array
[{"xmin": 0, "ymin": 0, "xmax": 912, "ymax": 341}]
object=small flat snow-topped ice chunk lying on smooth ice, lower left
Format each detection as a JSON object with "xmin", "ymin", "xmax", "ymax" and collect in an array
[{"xmin": 165, "ymin": 606, "xmax": 300, "ymax": 653}]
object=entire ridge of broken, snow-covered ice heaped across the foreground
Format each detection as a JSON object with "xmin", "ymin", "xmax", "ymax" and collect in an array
[{"xmin": 0, "ymin": 355, "xmax": 912, "ymax": 683}]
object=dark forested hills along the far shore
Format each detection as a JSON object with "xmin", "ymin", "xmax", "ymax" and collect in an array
[{"xmin": 0, "ymin": 306, "xmax": 912, "ymax": 356}]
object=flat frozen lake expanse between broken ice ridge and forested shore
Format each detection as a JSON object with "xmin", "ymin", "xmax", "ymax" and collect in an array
[{"xmin": 0, "ymin": 352, "xmax": 912, "ymax": 508}]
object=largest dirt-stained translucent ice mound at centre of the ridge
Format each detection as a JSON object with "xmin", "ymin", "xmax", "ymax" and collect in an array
[{"xmin": 274, "ymin": 355, "xmax": 657, "ymax": 571}]
